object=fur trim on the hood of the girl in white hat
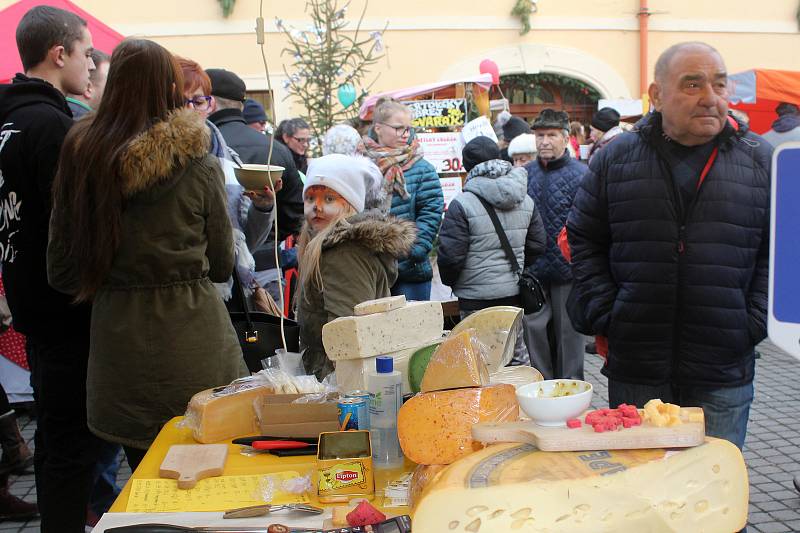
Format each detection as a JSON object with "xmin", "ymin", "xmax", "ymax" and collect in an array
[{"xmin": 322, "ymin": 211, "xmax": 417, "ymax": 258}]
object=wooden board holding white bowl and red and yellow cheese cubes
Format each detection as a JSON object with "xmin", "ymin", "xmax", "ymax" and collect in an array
[{"xmin": 472, "ymin": 407, "xmax": 706, "ymax": 452}]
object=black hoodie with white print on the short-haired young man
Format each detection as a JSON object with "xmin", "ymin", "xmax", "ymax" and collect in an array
[{"xmin": 0, "ymin": 74, "xmax": 90, "ymax": 341}]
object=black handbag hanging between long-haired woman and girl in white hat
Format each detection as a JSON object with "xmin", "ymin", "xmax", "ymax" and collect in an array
[{"xmin": 230, "ymin": 267, "xmax": 300, "ymax": 372}]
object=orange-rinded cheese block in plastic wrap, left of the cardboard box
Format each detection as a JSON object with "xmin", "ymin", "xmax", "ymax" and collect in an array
[{"xmin": 186, "ymin": 386, "xmax": 274, "ymax": 444}]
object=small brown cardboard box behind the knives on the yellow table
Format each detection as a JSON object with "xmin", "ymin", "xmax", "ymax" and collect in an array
[{"xmin": 256, "ymin": 394, "xmax": 339, "ymax": 437}]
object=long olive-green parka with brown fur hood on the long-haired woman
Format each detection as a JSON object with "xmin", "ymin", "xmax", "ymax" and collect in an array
[{"xmin": 47, "ymin": 110, "xmax": 245, "ymax": 448}]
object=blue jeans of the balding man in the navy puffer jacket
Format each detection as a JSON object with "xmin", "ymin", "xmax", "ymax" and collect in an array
[{"xmin": 608, "ymin": 379, "xmax": 753, "ymax": 450}]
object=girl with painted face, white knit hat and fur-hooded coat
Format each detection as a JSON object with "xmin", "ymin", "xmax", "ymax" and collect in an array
[{"xmin": 297, "ymin": 154, "xmax": 416, "ymax": 379}]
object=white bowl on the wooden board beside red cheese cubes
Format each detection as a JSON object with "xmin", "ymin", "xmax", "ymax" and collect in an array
[{"xmin": 517, "ymin": 379, "xmax": 592, "ymax": 426}]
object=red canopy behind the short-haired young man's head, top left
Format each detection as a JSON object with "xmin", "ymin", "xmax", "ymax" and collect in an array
[{"xmin": 0, "ymin": 0, "xmax": 125, "ymax": 81}]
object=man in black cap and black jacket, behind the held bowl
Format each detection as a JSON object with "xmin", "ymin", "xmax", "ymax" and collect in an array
[{"xmin": 206, "ymin": 68, "xmax": 303, "ymax": 301}]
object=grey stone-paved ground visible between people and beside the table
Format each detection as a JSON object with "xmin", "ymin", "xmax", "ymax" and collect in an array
[{"xmin": 0, "ymin": 342, "xmax": 800, "ymax": 533}]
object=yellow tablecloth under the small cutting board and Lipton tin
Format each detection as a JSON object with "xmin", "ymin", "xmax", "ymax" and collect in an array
[{"xmin": 109, "ymin": 417, "xmax": 415, "ymax": 515}]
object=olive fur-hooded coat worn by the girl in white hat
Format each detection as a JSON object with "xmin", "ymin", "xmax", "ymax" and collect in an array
[{"xmin": 297, "ymin": 213, "xmax": 417, "ymax": 379}]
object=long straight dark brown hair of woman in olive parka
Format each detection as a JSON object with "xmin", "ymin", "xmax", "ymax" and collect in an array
[{"xmin": 53, "ymin": 39, "xmax": 184, "ymax": 302}]
